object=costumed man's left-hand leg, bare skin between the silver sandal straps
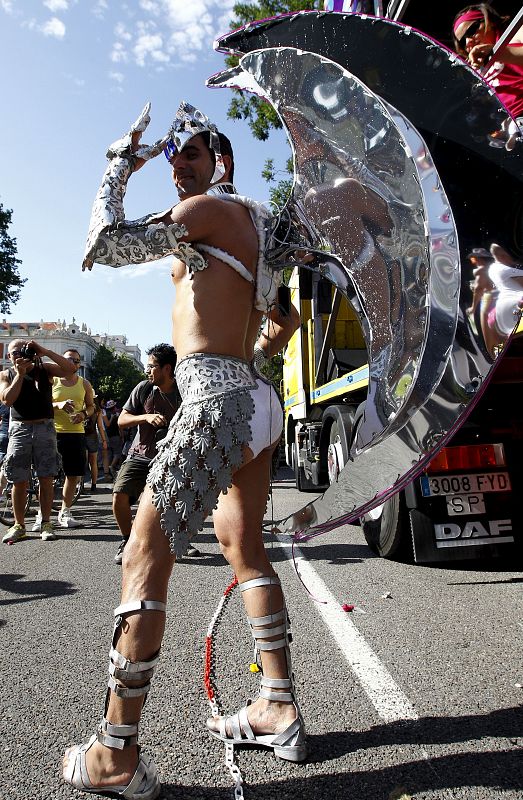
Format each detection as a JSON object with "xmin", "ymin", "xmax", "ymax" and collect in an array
[{"xmin": 64, "ymin": 487, "xmax": 174, "ymax": 787}]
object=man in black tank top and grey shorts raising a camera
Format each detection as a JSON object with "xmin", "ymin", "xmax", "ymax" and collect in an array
[{"xmin": 0, "ymin": 339, "xmax": 74, "ymax": 544}]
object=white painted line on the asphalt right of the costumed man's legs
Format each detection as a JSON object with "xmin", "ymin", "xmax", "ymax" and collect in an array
[{"xmin": 276, "ymin": 536, "xmax": 418, "ymax": 722}]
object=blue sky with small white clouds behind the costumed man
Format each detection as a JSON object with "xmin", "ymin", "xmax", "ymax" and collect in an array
[{"xmin": 0, "ymin": 0, "xmax": 288, "ymax": 357}]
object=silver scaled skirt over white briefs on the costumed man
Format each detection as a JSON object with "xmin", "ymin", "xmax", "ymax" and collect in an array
[{"xmin": 147, "ymin": 353, "xmax": 282, "ymax": 556}]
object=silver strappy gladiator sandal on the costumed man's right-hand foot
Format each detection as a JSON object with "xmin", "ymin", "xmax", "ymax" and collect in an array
[{"xmin": 209, "ymin": 576, "xmax": 307, "ymax": 761}]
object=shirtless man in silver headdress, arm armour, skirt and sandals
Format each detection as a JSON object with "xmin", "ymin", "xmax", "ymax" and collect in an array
[{"xmin": 64, "ymin": 103, "xmax": 306, "ymax": 800}]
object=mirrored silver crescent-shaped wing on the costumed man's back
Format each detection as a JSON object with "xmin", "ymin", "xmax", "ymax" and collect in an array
[{"xmin": 209, "ymin": 18, "xmax": 523, "ymax": 538}]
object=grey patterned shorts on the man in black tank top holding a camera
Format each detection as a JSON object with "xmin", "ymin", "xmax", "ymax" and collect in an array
[{"xmin": 2, "ymin": 419, "xmax": 58, "ymax": 483}]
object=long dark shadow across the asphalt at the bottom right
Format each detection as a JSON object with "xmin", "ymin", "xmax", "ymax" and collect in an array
[{"xmin": 161, "ymin": 708, "xmax": 523, "ymax": 800}]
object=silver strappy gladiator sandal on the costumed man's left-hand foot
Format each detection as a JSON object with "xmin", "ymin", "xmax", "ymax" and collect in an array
[{"xmin": 63, "ymin": 600, "xmax": 166, "ymax": 800}]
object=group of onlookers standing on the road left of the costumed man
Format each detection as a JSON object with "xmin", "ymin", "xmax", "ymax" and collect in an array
[{"xmin": 0, "ymin": 339, "xmax": 209, "ymax": 564}]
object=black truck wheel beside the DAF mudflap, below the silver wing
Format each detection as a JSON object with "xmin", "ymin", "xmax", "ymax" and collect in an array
[{"xmin": 361, "ymin": 492, "xmax": 413, "ymax": 561}]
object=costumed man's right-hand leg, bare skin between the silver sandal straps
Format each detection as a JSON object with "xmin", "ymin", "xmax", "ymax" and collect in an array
[{"xmin": 208, "ymin": 448, "xmax": 297, "ymax": 734}]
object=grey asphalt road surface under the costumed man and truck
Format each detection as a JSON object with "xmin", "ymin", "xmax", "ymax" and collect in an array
[{"xmin": 0, "ymin": 473, "xmax": 523, "ymax": 800}]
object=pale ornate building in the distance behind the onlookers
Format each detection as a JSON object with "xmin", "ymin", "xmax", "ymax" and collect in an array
[{"xmin": 0, "ymin": 317, "xmax": 143, "ymax": 380}]
